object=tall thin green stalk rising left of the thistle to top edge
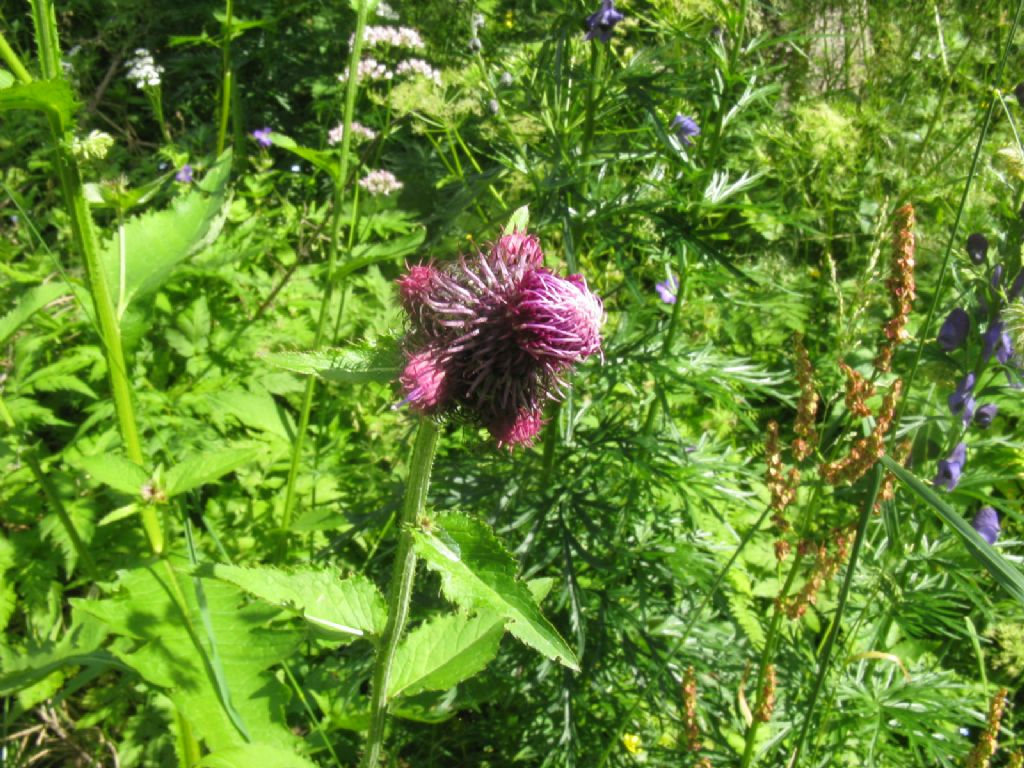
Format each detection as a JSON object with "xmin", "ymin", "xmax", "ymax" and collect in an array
[{"xmin": 281, "ymin": 0, "xmax": 370, "ymax": 542}]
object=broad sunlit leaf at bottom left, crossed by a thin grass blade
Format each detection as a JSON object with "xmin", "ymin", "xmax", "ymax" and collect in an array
[{"xmin": 72, "ymin": 563, "xmax": 302, "ymax": 753}]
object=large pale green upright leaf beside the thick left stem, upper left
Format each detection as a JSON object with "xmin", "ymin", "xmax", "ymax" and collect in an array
[{"xmin": 99, "ymin": 151, "xmax": 231, "ymax": 309}]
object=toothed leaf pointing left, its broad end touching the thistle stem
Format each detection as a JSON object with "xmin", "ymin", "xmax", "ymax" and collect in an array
[{"xmin": 213, "ymin": 565, "xmax": 387, "ymax": 636}]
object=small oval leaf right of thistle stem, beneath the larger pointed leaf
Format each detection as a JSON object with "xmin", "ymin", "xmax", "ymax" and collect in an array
[{"xmin": 387, "ymin": 613, "xmax": 505, "ymax": 698}]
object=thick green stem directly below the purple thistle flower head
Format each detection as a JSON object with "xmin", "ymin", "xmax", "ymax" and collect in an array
[{"xmin": 360, "ymin": 417, "xmax": 438, "ymax": 768}]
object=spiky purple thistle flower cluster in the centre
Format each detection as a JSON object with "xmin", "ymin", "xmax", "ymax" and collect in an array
[{"xmin": 398, "ymin": 232, "xmax": 603, "ymax": 447}]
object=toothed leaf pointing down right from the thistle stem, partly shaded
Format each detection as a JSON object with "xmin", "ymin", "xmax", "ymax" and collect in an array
[{"xmin": 413, "ymin": 515, "xmax": 579, "ymax": 670}]
